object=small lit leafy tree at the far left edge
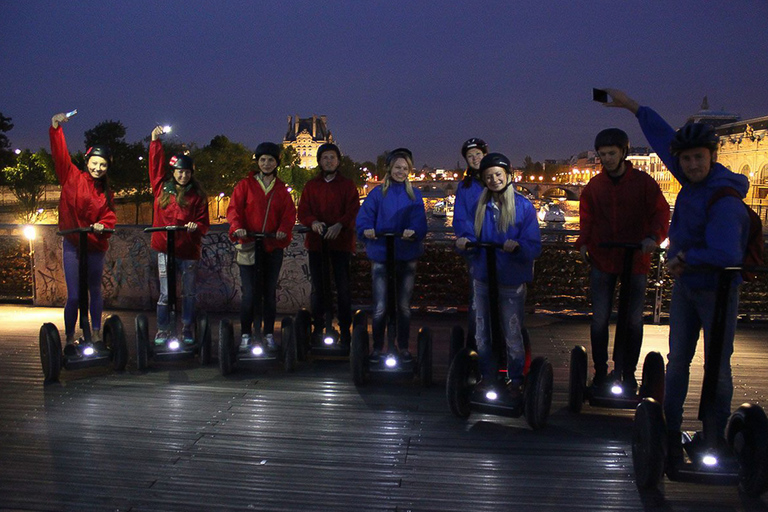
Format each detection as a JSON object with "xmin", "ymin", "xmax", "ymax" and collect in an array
[{"xmin": 2, "ymin": 149, "xmax": 47, "ymax": 223}]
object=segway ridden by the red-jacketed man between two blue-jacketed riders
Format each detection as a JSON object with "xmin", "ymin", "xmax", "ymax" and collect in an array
[{"xmin": 568, "ymin": 242, "xmax": 664, "ymax": 413}]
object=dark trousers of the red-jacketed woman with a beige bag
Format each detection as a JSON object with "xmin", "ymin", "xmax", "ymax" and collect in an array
[{"xmin": 238, "ymin": 249, "xmax": 283, "ymax": 334}]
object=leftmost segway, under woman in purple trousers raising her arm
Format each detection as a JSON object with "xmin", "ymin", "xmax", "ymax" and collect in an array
[{"xmin": 40, "ymin": 226, "xmax": 128, "ymax": 382}]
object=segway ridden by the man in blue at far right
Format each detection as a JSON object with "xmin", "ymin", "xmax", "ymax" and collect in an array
[{"xmin": 632, "ymin": 267, "xmax": 768, "ymax": 496}]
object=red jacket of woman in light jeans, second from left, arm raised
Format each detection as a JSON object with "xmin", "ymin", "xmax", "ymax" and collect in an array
[{"xmin": 149, "ymin": 140, "xmax": 211, "ymax": 260}]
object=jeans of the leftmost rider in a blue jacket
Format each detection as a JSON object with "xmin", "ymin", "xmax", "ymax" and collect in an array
[{"xmin": 371, "ymin": 260, "xmax": 416, "ymax": 350}]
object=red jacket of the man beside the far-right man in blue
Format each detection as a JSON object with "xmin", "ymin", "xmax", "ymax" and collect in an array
[{"xmin": 575, "ymin": 161, "xmax": 669, "ymax": 274}]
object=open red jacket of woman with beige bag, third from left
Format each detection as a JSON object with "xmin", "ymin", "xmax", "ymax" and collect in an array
[{"xmin": 227, "ymin": 171, "xmax": 296, "ymax": 252}]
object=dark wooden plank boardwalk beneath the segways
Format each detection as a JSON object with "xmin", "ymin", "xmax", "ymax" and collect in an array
[{"xmin": 0, "ymin": 306, "xmax": 768, "ymax": 512}]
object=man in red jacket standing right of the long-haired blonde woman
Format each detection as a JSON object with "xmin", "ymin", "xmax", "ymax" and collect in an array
[{"xmin": 575, "ymin": 128, "xmax": 669, "ymax": 392}]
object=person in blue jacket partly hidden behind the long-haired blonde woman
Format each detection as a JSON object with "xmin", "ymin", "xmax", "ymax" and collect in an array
[{"xmin": 453, "ymin": 137, "xmax": 488, "ymax": 342}]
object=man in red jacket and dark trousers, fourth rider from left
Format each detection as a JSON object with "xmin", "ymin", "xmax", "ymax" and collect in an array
[{"xmin": 299, "ymin": 143, "xmax": 360, "ymax": 345}]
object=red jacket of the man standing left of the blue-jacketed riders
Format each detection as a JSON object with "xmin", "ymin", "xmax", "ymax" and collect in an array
[{"xmin": 299, "ymin": 172, "xmax": 360, "ymax": 253}]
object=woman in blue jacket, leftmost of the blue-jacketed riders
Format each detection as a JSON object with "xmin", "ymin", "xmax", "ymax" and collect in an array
[{"xmin": 357, "ymin": 148, "xmax": 427, "ymax": 363}]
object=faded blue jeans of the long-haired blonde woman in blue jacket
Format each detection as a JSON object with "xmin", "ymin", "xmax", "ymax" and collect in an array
[{"xmin": 472, "ymin": 280, "xmax": 526, "ymax": 383}]
